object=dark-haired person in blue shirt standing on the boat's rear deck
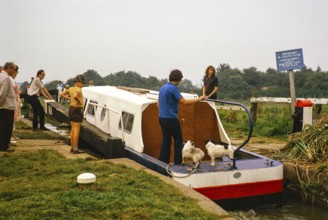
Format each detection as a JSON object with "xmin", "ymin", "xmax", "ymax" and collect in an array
[{"xmin": 157, "ymin": 69, "xmax": 204, "ymax": 164}]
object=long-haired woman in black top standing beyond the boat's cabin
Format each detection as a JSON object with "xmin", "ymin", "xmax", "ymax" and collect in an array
[{"xmin": 203, "ymin": 66, "xmax": 219, "ymax": 99}]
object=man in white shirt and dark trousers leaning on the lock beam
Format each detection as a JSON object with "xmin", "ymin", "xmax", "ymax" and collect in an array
[{"xmin": 27, "ymin": 70, "xmax": 53, "ymax": 131}]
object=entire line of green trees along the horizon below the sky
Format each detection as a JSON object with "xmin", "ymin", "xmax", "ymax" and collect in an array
[{"xmin": 21, "ymin": 63, "xmax": 328, "ymax": 100}]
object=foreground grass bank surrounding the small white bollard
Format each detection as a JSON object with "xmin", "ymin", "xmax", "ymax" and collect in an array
[{"xmin": 0, "ymin": 150, "xmax": 222, "ymax": 219}]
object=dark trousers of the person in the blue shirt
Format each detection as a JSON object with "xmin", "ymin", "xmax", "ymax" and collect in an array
[{"xmin": 159, "ymin": 117, "xmax": 183, "ymax": 164}]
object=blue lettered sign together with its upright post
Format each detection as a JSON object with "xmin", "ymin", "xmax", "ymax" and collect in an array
[{"xmin": 276, "ymin": 49, "xmax": 304, "ymax": 114}]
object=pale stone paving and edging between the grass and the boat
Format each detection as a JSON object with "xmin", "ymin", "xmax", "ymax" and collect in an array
[{"xmin": 0, "ymin": 119, "xmax": 234, "ymax": 220}]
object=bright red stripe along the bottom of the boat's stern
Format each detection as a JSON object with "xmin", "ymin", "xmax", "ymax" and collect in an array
[{"xmin": 194, "ymin": 179, "xmax": 283, "ymax": 200}]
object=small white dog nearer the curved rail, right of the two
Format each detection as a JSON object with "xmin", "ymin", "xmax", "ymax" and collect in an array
[{"xmin": 205, "ymin": 140, "xmax": 234, "ymax": 167}]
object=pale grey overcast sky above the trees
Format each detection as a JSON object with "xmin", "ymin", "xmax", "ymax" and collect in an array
[{"xmin": 0, "ymin": 0, "xmax": 328, "ymax": 85}]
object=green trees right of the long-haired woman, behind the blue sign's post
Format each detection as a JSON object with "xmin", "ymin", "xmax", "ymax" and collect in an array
[{"xmin": 217, "ymin": 64, "xmax": 328, "ymax": 99}]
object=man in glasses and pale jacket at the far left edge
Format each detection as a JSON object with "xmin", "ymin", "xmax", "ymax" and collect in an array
[{"xmin": 0, "ymin": 62, "xmax": 17, "ymax": 152}]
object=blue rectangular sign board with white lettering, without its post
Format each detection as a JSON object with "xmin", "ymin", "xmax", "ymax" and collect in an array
[{"xmin": 276, "ymin": 49, "xmax": 304, "ymax": 71}]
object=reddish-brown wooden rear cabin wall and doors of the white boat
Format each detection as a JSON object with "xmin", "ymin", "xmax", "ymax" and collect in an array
[{"xmin": 142, "ymin": 102, "xmax": 221, "ymax": 162}]
